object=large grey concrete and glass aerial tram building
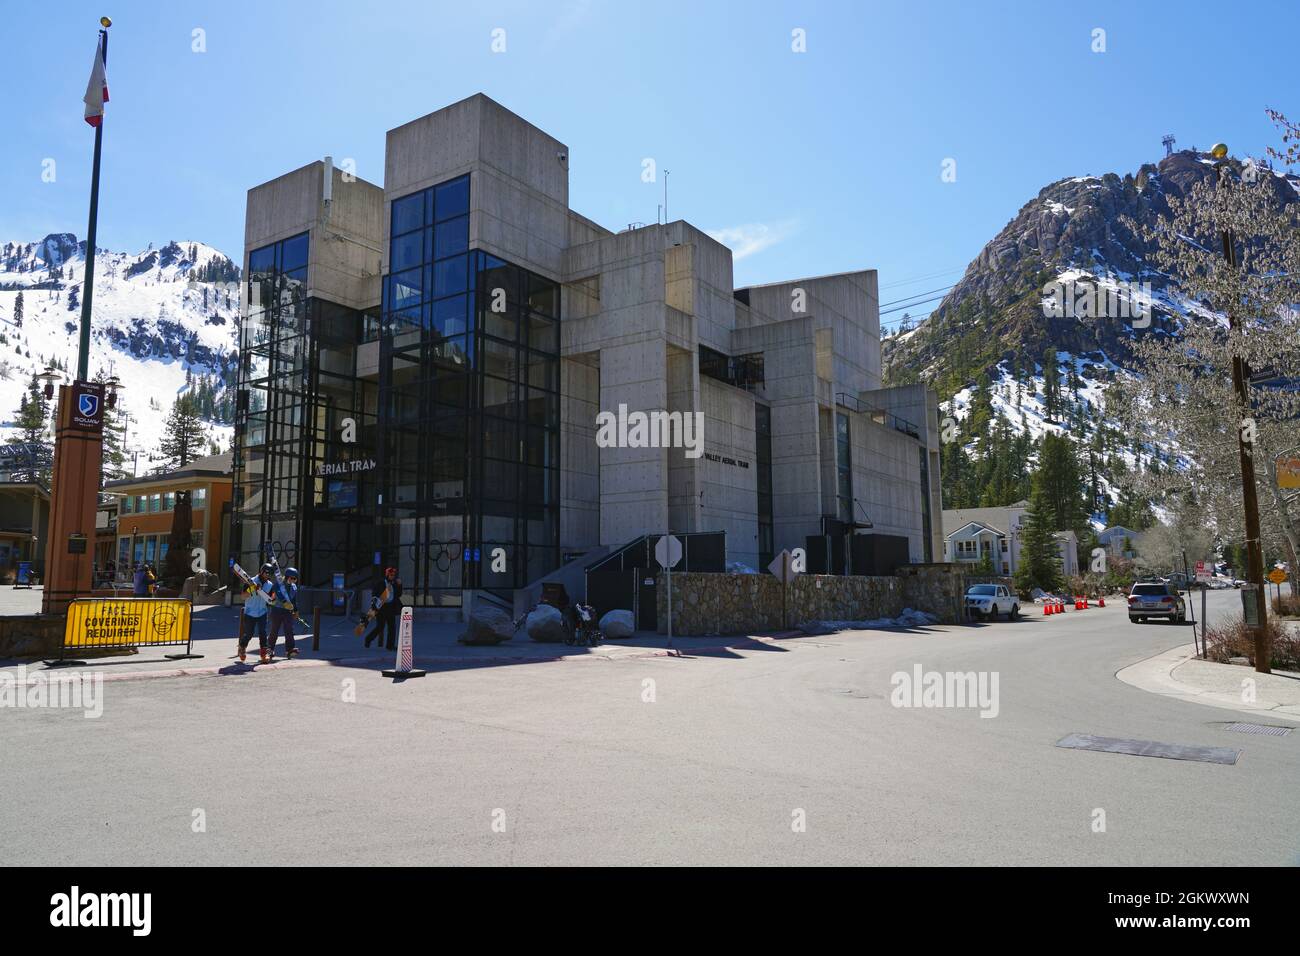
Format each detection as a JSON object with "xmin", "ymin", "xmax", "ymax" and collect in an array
[{"xmin": 233, "ymin": 95, "xmax": 943, "ymax": 607}]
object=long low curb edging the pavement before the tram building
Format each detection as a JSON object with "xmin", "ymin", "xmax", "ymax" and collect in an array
[{"xmin": 7, "ymin": 631, "xmax": 807, "ymax": 685}]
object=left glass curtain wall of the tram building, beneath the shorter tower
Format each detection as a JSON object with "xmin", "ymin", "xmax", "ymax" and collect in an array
[{"xmin": 231, "ymin": 233, "xmax": 378, "ymax": 585}]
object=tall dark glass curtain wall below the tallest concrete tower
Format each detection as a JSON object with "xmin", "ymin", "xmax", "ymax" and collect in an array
[{"xmin": 378, "ymin": 176, "xmax": 559, "ymax": 606}]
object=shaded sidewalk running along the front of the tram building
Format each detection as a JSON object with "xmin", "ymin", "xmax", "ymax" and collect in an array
[{"xmin": 0, "ymin": 606, "xmax": 806, "ymax": 680}]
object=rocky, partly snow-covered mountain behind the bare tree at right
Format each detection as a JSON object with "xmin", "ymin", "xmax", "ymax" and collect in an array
[{"xmin": 883, "ymin": 150, "xmax": 1300, "ymax": 524}]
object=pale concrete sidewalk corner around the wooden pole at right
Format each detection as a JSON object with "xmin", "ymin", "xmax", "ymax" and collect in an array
[{"xmin": 1115, "ymin": 644, "xmax": 1300, "ymax": 724}]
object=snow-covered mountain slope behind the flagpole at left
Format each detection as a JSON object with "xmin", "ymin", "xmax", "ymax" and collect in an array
[{"xmin": 0, "ymin": 233, "xmax": 239, "ymax": 473}]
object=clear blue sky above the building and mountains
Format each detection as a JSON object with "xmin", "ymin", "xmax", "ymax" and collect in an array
[{"xmin": 0, "ymin": 0, "xmax": 1300, "ymax": 320}]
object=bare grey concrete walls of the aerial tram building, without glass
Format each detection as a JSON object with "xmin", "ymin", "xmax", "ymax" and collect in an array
[{"xmin": 239, "ymin": 95, "xmax": 943, "ymax": 600}]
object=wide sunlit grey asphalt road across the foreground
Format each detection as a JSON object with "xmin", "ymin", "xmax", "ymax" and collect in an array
[{"xmin": 0, "ymin": 592, "xmax": 1300, "ymax": 865}]
